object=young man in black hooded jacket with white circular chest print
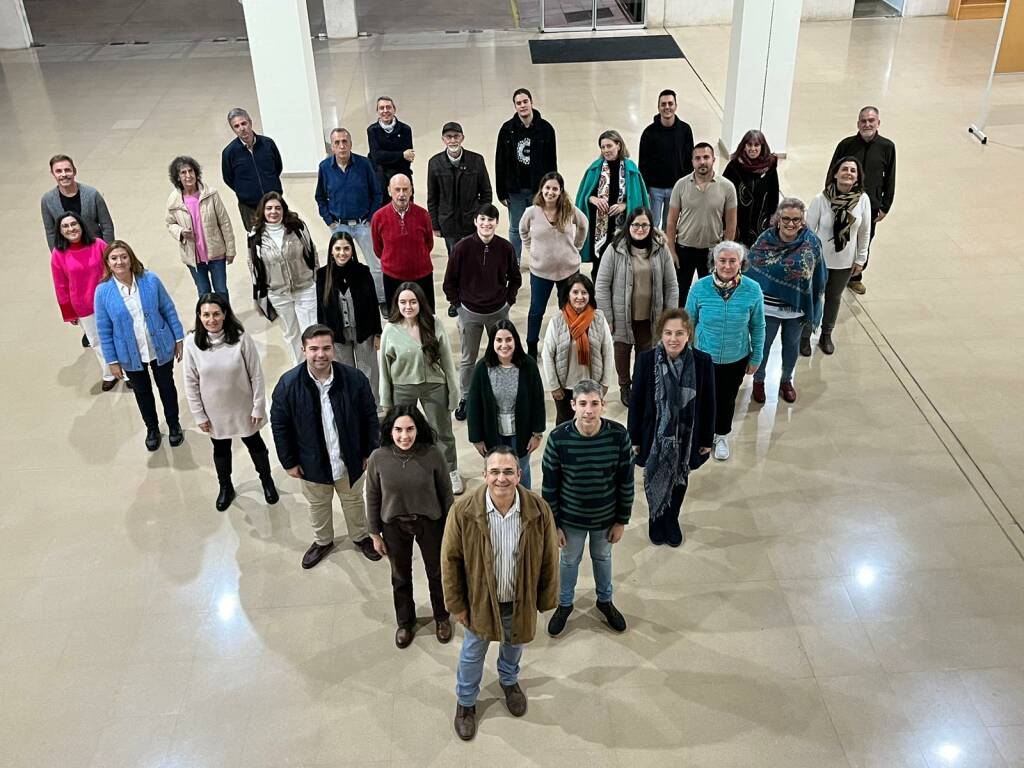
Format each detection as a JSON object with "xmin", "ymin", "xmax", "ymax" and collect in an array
[{"xmin": 495, "ymin": 88, "xmax": 558, "ymax": 261}]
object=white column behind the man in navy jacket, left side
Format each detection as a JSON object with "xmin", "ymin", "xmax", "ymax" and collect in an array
[{"xmin": 242, "ymin": 0, "xmax": 324, "ymax": 175}]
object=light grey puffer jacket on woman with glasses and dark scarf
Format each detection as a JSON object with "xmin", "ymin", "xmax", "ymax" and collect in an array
[{"xmin": 594, "ymin": 240, "xmax": 679, "ymax": 344}]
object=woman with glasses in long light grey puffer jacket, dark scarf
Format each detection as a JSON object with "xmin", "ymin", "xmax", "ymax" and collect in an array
[{"xmin": 594, "ymin": 207, "xmax": 679, "ymax": 408}]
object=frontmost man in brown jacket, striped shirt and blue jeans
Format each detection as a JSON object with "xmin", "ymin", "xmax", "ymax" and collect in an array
[{"xmin": 441, "ymin": 445, "xmax": 558, "ymax": 741}]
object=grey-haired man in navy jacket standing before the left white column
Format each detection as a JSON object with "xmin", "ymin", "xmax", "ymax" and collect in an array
[{"xmin": 220, "ymin": 106, "xmax": 284, "ymax": 231}]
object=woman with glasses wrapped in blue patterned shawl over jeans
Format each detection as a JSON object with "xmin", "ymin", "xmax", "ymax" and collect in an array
[{"xmin": 746, "ymin": 198, "xmax": 828, "ymax": 402}]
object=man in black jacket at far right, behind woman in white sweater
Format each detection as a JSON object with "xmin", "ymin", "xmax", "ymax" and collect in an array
[{"xmin": 825, "ymin": 106, "xmax": 896, "ymax": 294}]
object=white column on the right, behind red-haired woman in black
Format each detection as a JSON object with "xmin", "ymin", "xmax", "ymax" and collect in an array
[{"xmin": 721, "ymin": 0, "xmax": 802, "ymax": 153}]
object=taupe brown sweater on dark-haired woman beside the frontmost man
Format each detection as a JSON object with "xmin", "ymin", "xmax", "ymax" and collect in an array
[{"xmin": 367, "ymin": 445, "xmax": 455, "ymax": 534}]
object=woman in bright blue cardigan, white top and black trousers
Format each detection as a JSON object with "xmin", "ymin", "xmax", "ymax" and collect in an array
[{"xmin": 94, "ymin": 240, "xmax": 185, "ymax": 451}]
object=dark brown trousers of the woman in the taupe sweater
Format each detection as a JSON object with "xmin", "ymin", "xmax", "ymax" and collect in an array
[{"xmin": 381, "ymin": 515, "xmax": 449, "ymax": 628}]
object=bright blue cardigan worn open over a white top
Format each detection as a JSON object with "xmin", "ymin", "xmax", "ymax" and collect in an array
[{"xmin": 94, "ymin": 271, "xmax": 185, "ymax": 371}]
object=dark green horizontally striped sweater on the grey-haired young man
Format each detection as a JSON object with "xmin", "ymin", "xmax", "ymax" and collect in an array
[{"xmin": 542, "ymin": 419, "xmax": 633, "ymax": 530}]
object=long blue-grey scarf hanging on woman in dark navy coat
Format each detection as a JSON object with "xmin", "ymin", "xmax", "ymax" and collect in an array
[{"xmin": 643, "ymin": 342, "xmax": 697, "ymax": 520}]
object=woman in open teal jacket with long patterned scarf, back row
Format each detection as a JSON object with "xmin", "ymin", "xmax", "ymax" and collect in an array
[{"xmin": 575, "ymin": 131, "xmax": 650, "ymax": 282}]
